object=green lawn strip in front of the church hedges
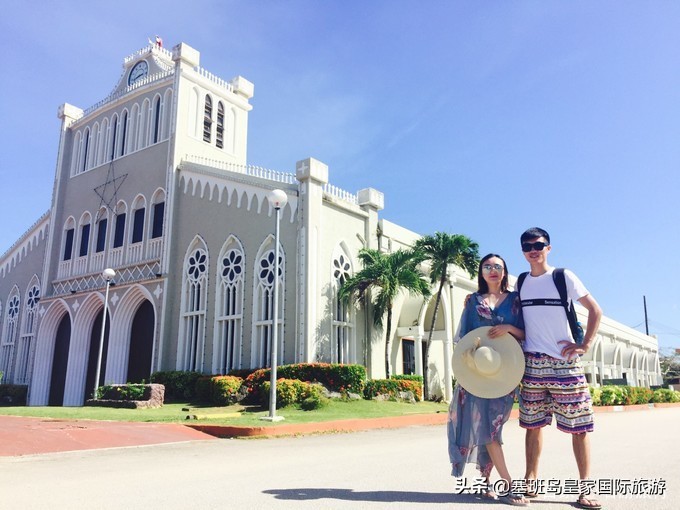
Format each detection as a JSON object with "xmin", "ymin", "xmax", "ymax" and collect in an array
[{"xmin": 0, "ymin": 400, "xmax": 447, "ymax": 427}]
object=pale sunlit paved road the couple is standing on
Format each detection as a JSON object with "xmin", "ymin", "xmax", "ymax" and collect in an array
[{"xmin": 0, "ymin": 408, "xmax": 680, "ymax": 510}]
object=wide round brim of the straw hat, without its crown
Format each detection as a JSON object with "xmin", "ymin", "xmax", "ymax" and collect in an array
[{"xmin": 453, "ymin": 326, "xmax": 524, "ymax": 398}]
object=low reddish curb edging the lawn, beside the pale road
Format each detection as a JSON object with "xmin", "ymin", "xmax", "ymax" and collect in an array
[{"xmin": 185, "ymin": 403, "xmax": 680, "ymax": 438}]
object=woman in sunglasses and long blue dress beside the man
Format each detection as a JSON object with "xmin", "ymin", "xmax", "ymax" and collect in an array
[{"xmin": 448, "ymin": 253, "xmax": 528, "ymax": 506}]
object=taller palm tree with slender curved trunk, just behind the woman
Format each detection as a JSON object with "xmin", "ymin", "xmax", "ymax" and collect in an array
[{"xmin": 414, "ymin": 232, "xmax": 479, "ymax": 400}]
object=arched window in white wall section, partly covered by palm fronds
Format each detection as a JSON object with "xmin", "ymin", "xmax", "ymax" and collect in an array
[{"xmin": 331, "ymin": 249, "xmax": 354, "ymax": 363}]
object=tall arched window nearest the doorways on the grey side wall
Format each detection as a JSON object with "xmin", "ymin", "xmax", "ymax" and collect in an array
[{"xmin": 177, "ymin": 239, "xmax": 208, "ymax": 372}]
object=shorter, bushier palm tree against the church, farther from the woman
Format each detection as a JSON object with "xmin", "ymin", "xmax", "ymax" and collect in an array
[{"xmin": 339, "ymin": 248, "xmax": 430, "ymax": 379}]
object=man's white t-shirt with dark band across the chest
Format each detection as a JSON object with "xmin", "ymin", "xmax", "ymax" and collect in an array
[{"xmin": 520, "ymin": 267, "xmax": 589, "ymax": 359}]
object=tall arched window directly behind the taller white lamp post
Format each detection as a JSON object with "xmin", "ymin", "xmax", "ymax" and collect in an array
[{"xmin": 251, "ymin": 238, "xmax": 285, "ymax": 367}]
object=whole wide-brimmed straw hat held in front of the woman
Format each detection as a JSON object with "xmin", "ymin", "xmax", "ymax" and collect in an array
[{"xmin": 453, "ymin": 326, "xmax": 524, "ymax": 398}]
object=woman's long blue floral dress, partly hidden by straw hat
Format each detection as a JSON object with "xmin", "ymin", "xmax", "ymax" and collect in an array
[{"xmin": 447, "ymin": 292, "xmax": 524, "ymax": 477}]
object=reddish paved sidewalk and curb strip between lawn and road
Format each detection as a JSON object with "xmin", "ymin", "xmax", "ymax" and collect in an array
[{"xmin": 0, "ymin": 404, "xmax": 680, "ymax": 457}]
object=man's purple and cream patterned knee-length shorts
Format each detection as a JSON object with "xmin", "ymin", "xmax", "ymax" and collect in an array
[{"xmin": 519, "ymin": 352, "xmax": 593, "ymax": 434}]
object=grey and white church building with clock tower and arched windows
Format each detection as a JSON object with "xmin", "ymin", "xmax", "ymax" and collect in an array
[{"xmin": 0, "ymin": 43, "xmax": 661, "ymax": 406}]
